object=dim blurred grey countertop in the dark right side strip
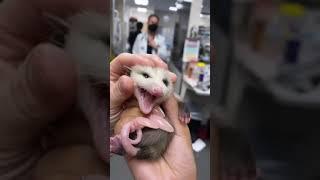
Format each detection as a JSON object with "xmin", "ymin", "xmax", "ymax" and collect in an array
[{"xmin": 235, "ymin": 42, "xmax": 320, "ymax": 107}]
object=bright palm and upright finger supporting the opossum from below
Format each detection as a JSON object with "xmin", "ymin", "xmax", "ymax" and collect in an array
[{"xmin": 126, "ymin": 96, "xmax": 196, "ymax": 180}]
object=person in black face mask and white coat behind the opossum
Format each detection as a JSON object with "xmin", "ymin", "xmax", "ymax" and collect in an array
[{"xmin": 132, "ymin": 14, "xmax": 167, "ymax": 60}]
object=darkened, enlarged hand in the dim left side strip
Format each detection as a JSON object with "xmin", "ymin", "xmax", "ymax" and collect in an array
[{"xmin": 0, "ymin": 0, "xmax": 108, "ymax": 179}]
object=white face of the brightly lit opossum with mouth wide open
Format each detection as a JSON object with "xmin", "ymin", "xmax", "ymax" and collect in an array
[{"xmin": 130, "ymin": 65, "xmax": 173, "ymax": 114}]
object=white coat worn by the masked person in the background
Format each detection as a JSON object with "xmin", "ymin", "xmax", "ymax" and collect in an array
[{"xmin": 132, "ymin": 32, "xmax": 168, "ymax": 62}]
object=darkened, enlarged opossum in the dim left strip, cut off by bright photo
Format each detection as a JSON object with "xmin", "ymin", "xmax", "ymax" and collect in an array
[{"xmin": 44, "ymin": 12, "xmax": 109, "ymax": 161}]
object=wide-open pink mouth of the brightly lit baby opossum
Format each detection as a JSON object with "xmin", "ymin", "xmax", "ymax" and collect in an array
[{"xmin": 135, "ymin": 88, "xmax": 157, "ymax": 114}]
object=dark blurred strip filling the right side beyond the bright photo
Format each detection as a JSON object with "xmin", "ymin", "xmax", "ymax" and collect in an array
[{"xmin": 211, "ymin": 0, "xmax": 320, "ymax": 180}]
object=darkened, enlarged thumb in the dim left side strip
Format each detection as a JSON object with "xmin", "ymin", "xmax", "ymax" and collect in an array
[{"xmin": 0, "ymin": 44, "xmax": 77, "ymax": 146}]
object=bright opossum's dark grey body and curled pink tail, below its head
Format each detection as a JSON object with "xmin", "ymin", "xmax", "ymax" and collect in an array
[{"xmin": 110, "ymin": 107, "xmax": 173, "ymax": 160}]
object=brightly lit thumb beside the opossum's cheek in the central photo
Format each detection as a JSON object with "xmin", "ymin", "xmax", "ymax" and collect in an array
[{"xmin": 110, "ymin": 75, "xmax": 133, "ymax": 110}]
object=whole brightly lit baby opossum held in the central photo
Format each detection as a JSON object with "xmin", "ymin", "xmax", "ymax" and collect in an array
[{"xmin": 110, "ymin": 65, "xmax": 189, "ymax": 160}]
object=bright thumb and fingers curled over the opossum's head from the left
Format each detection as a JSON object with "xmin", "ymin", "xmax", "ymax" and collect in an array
[{"xmin": 110, "ymin": 53, "xmax": 177, "ymax": 126}]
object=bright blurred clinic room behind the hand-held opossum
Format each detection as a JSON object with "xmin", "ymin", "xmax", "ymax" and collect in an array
[{"xmin": 110, "ymin": 0, "xmax": 213, "ymax": 180}]
